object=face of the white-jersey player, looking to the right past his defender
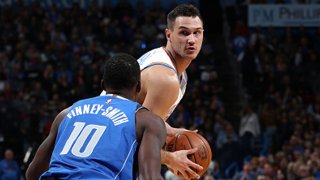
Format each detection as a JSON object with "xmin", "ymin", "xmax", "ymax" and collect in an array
[{"xmin": 169, "ymin": 16, "xmax": 203, "ymax": 59}]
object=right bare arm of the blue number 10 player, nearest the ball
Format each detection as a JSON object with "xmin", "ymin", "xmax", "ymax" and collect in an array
[{"xmin": 136, "ymin": 109, "xmax": 166, "ymax": 180}]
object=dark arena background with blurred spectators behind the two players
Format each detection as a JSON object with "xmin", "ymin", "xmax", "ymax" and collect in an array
[{"xmin": 0, "ymin": 0, "xmax": 320, "ymax": 179}]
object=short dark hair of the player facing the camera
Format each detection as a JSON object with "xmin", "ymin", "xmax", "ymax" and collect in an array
[{"xmin": 167, "ymin": 4, "xmax": 202, "ymax": 29}]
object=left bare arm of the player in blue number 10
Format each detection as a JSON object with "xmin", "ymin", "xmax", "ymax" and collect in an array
[{"xmin": 26, "ymin": 108, "xmax": 69, "ymax": 180}]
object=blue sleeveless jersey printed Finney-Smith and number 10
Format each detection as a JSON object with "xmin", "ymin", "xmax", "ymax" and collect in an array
[{"xmin": 40, "ymin": 95, "xmax": 140, "ymax": 180}]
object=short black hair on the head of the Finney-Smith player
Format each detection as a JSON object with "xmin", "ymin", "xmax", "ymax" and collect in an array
[{"xmin": 103, "ymin": 53, "xmax": 140, "ymax": 90}]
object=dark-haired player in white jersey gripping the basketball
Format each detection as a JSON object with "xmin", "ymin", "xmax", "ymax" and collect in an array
[{"xmin": 103, "ymin": 4, "xmax": 204, "ymax": 179}]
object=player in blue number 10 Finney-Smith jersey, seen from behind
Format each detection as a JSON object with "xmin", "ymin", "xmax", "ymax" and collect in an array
[{"xmin": 26, "ymin": 54, "xmax": 166, "ymax": 180}]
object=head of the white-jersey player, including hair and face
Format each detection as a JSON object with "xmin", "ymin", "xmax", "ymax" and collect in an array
[{"xmin": 166, "ymin": 4, "xmax": 203, "ymax": 60}]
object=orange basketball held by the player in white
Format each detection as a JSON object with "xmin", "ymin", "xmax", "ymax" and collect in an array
[{"xmin": 165, "ymin": 131, "xmax": 212, "ymax": 176}]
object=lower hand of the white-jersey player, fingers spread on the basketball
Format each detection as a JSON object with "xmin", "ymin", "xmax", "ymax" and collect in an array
[{"xmin": 166, "ymin": 148, "xmax": 203, "ymax": 179}]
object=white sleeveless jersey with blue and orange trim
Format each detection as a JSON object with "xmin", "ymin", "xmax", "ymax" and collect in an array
[{"xmin": 138, "ymin": 47, "xmax": 188, "ymax": 120}]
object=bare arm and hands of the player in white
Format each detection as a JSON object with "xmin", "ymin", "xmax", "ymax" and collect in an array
[{"xmin": 141, "ymin": 66, "xmax": 202, "ymax": 179}]
